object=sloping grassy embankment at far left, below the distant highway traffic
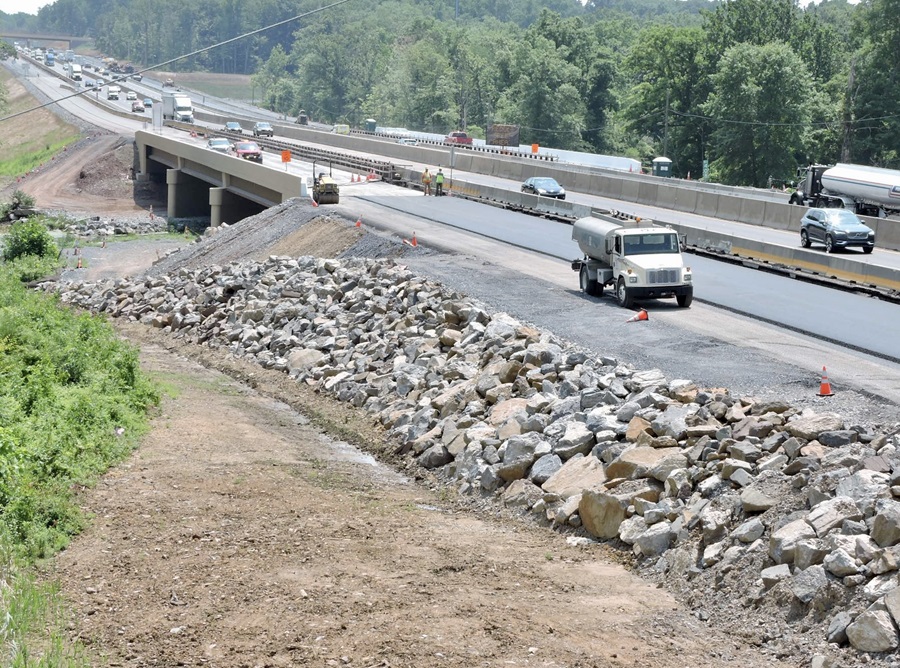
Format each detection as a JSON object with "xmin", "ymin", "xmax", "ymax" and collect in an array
[{"xmin": 0, "ymin": 68, "xmax": 80, "ymax": 189}]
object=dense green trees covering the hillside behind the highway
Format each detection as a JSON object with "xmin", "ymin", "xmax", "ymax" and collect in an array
[{"xmin": 0, "ymin": 0, "xmax": 900, "ymax": 185}]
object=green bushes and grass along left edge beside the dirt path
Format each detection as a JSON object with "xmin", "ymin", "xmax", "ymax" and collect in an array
[{"xmin": 0, "ymin": 197, "xmax": 159, "ymax": 668}]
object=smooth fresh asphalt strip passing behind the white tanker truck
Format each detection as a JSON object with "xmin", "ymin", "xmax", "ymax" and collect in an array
[{"xmin": 366, "ymin": 190, "xmax": 900, "ymax": 363}]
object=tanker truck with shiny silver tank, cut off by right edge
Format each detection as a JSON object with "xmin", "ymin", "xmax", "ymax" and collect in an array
[{"xmin": 790, "ymin": 163, "xmax": 900, "ymax": 218}]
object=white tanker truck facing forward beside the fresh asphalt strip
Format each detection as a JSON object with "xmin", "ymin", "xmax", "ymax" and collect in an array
[{"xmin": 572, "ymin": 214, "xmax": 694, "ymax": 308}]
